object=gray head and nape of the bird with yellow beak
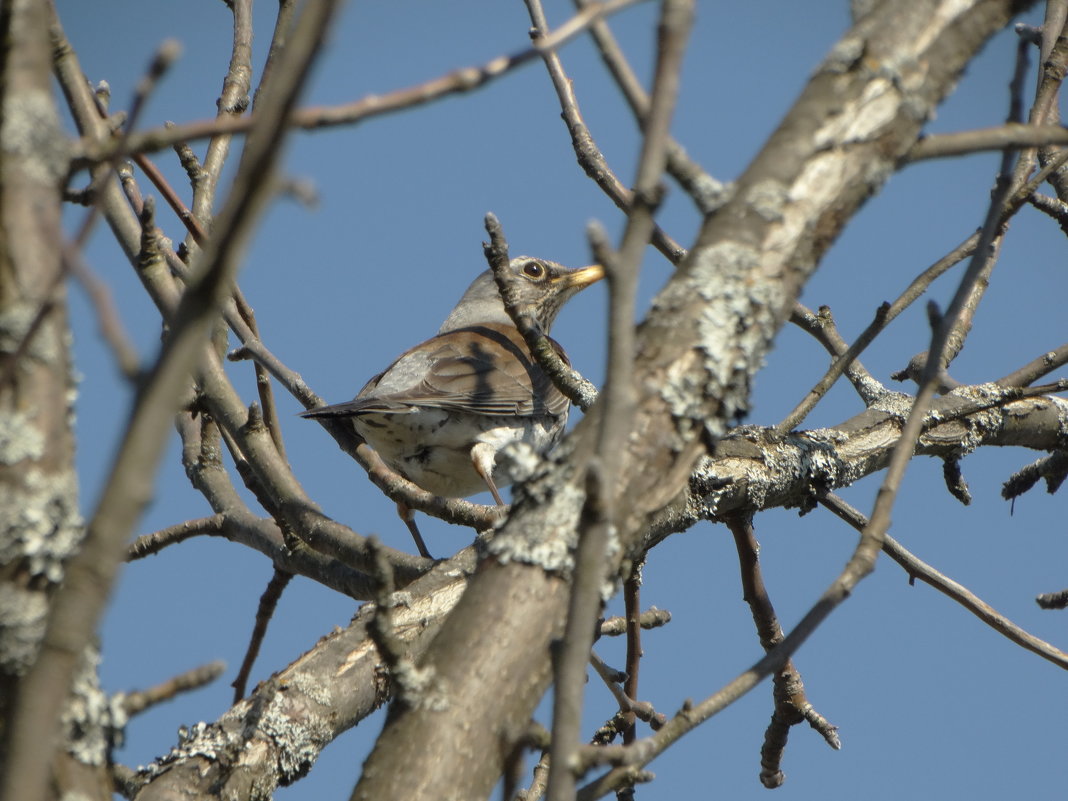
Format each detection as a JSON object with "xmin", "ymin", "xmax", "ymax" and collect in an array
[{"xmin": 438, "ymin": 256, "xmax": 604, "ymax": 333}]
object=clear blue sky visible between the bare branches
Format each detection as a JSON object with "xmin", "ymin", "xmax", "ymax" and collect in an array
[{"xmin": 58, "ymin": 0, "xmax": 1068, "ymax": 801}]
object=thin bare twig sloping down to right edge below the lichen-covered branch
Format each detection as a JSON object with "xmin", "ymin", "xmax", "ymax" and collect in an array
[{"xmin": 819, "ymin": 492, "xmax": 1068, "ymax": 670}]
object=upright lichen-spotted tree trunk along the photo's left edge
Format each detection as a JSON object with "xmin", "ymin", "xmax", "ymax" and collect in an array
[{"xmin": 0, "ymin": 0, "xmax": 111, "ymax": 801}]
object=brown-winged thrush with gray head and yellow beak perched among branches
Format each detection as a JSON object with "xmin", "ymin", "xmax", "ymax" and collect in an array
[{"xmin": 301, "ymin": 256, "xmax": 604, "ymax": 557}]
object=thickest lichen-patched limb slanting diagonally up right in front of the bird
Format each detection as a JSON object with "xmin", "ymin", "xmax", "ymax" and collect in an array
[{"xmin": 352, "ymin": 0, "xmax": 1025, "ymax": 801}]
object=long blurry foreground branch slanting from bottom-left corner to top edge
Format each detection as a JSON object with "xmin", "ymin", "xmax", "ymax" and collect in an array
[{"xmin": 3, "ymin": 9, "xmax": 335, "ymax": 799}]
